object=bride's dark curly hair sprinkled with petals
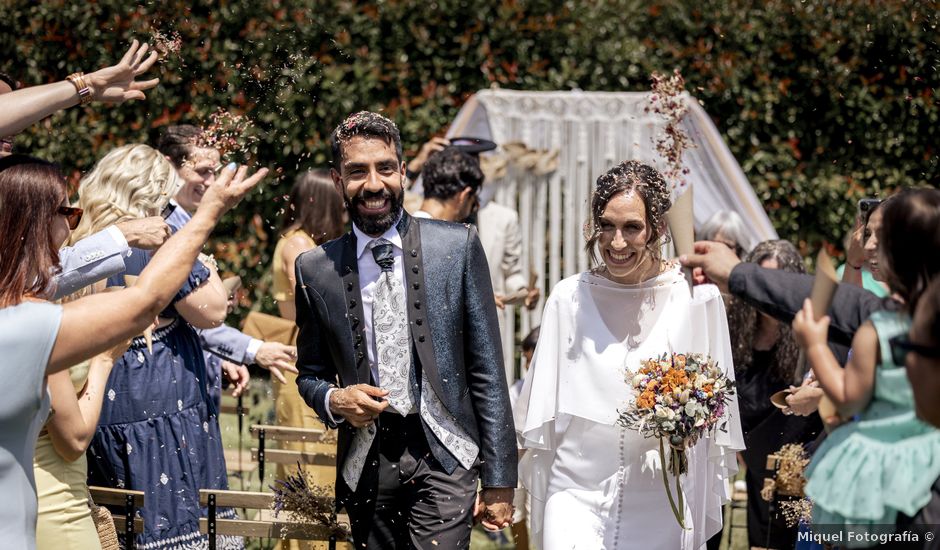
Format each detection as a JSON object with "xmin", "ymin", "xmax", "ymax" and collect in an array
[{"xmin": 584, "ymin": 160, "xmax": 672, "ymax": 263}]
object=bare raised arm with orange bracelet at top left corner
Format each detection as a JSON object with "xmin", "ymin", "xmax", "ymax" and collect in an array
[{"xmin": 0, "ymin": 40, "xmax": 159, "ymax": 136}]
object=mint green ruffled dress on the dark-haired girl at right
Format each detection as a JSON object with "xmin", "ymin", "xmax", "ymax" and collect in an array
[{"xmin": 806, "ymin": 311, "xmax": 940, "ymax": 548}]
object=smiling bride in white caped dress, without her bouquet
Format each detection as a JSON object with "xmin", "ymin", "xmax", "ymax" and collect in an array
[{"xmin": 515, "ymin": 161, "xmax": 744, "ymax": 550}]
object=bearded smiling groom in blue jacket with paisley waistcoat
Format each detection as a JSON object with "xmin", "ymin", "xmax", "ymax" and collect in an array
[{"xmin": 296, "ymin": 112, "xmax": 517, "ymax": 549}]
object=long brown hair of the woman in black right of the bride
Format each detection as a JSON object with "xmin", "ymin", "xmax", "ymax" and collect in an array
[{"xmin": 728, "ymin": 240, "xmax": 806, "ymax": 383}]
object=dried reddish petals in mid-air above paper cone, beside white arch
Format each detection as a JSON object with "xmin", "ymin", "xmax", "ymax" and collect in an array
[{"xmin": 646, "ymin": 69, "xmax": 694, "ymax": 192}]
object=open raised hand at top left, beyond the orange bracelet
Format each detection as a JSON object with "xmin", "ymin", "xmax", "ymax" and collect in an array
[{"xmin": 85, "ymin": 40, "xmax": 160, "ymax": 103}]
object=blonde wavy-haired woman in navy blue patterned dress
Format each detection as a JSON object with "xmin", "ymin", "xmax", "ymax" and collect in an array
[{"xmin": 36, "ymin": 145, "xmax": 239, "ymax": 548}]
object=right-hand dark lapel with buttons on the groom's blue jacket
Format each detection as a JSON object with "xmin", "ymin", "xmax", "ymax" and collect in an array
[{"xmin": 398, "ymin": 213, "xmax": 444, "ymax": 402}]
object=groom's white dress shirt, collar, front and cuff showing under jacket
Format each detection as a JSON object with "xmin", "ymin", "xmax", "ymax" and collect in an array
[{"xmin": 326, "ymin": 222, "xmax": 405, "ymax": 423}]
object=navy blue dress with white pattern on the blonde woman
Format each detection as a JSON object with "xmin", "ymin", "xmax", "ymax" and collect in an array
[{"xmin": 88, "ymin": 249, "xmax": 242, "ymax": 550}]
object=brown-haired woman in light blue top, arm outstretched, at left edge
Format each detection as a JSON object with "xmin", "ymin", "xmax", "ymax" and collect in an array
[{"xmin": 0, "ymin": 155, "xmax": 267, "ymax": 550}]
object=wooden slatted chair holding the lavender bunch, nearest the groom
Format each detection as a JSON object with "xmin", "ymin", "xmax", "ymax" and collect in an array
[{"xmin": 199, "ymin": 489, "xmax": 348, "ymax": 550}]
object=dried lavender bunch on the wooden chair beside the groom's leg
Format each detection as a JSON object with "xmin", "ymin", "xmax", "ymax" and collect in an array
[{"xmin": 269, "ymin": 462, "xmax": 350, "ymax": 536}]
